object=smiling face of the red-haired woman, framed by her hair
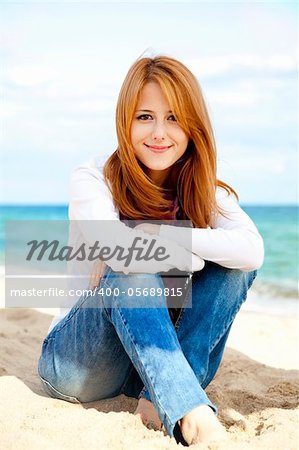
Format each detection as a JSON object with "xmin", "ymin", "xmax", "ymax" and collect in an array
[{"xmin": 131, "ymin": 82, "xmax": 188, "ymax": 185}]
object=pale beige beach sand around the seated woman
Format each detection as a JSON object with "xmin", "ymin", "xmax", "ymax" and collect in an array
[{"xmin": 0, "ymin": 309, "xmax": 299, "ymax": 450}]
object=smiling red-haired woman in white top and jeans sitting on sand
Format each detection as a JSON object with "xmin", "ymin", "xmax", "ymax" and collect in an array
[{"xmin": 38, "ymin": 56, "xmax": 264, "ymax": 445}]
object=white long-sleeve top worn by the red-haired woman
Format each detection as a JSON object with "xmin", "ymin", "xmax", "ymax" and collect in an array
[{"xmin": 49, "ymin": 156, "xmax": 264, "ymax": 331}]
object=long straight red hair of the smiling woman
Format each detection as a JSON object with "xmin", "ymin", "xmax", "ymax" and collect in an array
[{"xmin": 104, "ymin": 56, "xmax": 239, "ymax": 228}]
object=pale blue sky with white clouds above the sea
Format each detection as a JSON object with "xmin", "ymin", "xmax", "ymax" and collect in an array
[{"xmin": 0, "ymin": 0, "xmax": 298, "ymax": 205}]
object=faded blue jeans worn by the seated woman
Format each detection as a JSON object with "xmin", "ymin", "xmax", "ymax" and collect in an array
[{"xmin": 38, "ymin": 262, "xmax": 256, "ymax": 437}]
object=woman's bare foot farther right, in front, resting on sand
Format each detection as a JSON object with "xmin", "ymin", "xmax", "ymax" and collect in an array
[{"xmin": 179, "ymin": 405, "xmax": 227, "ymax": 445}]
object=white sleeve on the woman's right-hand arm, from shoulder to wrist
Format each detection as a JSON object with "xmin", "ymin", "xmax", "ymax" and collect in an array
[{"xmin": 159, "ymin": 188, "xmax": 264, "ymax": 272}]
